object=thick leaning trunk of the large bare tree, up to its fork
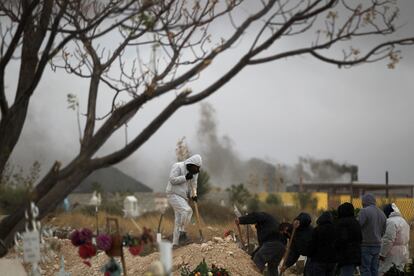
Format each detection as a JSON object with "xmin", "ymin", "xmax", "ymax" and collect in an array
[{"xmin": 0, "ymin": 96, "xmax": 188, "ymax": 246}]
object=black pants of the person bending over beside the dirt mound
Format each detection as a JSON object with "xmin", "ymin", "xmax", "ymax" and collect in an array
[{"xmin": 253, "ymin": 241, "xmax": 285, "ymax": 276}]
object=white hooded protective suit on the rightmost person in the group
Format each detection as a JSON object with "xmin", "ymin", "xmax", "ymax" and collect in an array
[{"xmin": 379, "ymin": 203, "xmax": 410, "ymax": 275}]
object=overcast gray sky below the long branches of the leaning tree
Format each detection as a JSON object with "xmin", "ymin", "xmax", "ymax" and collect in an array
[{"xmin": 9, "ymin": 0, "xmax": 414, "ymax": 189}]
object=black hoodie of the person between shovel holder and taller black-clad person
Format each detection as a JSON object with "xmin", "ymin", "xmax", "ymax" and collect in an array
[{"xmin": 309, "ymin": 212, "xmax": 336, "ymax": 263}]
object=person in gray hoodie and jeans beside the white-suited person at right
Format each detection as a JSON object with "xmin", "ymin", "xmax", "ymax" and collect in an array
[{"xmin": 358, "ymin": 194, "xmax": 387, "ymax": 276}]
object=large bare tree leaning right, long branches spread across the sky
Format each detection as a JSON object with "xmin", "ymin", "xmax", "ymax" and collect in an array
[{"xmin": 0, "ymin": 0, "xmax": 414, "ymax": 246}]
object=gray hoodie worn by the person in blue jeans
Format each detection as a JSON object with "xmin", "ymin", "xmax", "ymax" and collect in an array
[{"xmin": 358, "ymin": 194, "xmax": 387, "ymax": 246}]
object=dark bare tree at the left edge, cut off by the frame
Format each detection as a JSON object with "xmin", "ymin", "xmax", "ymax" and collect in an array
[{"xmin": 0, "ymin": 0, "xmax": 145, "ymax": 175}]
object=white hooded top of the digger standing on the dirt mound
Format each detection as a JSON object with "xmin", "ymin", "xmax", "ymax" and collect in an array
[{"xmin": 166, "ymin": 154, "xmax": 202, "ymax": 199}]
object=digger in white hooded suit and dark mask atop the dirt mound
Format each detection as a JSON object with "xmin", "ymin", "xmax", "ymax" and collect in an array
[{"xmin": 166, "ymin": 154, "xmax": 202, "ymax": 245}]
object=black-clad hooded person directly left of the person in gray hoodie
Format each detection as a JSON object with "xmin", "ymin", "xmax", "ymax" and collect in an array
[{"xmin": 335, "ymin": 202, "xmax": 362, "ymax": 276}]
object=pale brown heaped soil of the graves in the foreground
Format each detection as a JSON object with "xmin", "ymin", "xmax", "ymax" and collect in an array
[{"xmin": 8, "ymin": 238, "xmax": 272, "ymax": 276}]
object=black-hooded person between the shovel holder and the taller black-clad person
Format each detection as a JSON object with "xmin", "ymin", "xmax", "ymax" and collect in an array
[{"xmin": 308, "ymin": 212, "xmax": 336, "ymax": 276}]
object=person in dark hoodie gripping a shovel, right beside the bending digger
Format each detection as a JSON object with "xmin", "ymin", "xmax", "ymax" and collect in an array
[{"xmin": 281, "ymin": 213, "xmax": 313, "ymax": 276}]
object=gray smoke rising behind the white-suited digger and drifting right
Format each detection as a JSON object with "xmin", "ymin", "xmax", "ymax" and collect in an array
[{"xmin": 198, "ymin": 103, "xmax": 358, "ymax": 192}]
